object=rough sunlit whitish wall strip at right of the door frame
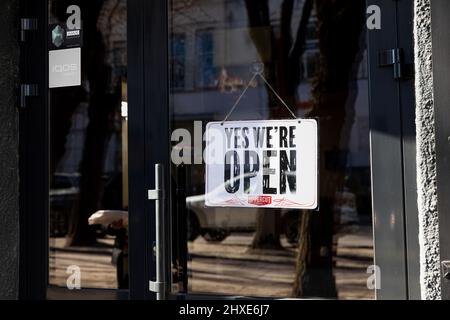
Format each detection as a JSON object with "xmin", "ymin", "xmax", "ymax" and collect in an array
[{"xmin": 414, "ymin": 0, "xmax": 441, "ymax": 299}]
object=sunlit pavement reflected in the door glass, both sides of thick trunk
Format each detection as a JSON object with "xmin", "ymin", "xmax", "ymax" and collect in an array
[{"xmin": 189, "ymin": 227, "xmax": 374, "ymax": 299}]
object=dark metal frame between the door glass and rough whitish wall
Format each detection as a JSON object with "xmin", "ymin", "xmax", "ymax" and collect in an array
[{"xmin": 367, "ymin": 0, "xmax": 420, "ymax": 299}]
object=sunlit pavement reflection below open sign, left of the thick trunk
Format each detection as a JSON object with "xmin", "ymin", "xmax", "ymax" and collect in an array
[{"xmin": 189, "ymin": 233, "xmax": 295, "ymax": 297}]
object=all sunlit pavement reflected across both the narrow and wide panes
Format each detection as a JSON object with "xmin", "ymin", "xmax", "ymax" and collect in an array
[{"xmin": 50, "ymin": 227, "xmax": 374, "ymax": 299}]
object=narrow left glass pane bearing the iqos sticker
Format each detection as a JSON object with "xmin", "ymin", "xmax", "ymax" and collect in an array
[{"xmin": 48, "ymin": 0, "xmax": 128, "ymax": 289}]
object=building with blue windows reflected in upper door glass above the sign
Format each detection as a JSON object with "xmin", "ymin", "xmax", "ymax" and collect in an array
[{"xmin": 171, "ymin": 0, "xmax": 369, "ymax": 167}]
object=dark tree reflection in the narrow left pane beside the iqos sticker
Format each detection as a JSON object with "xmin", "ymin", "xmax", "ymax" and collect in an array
[{"xmin": 50, "ymin": 0, "xmax": 126, "ymax": 246}]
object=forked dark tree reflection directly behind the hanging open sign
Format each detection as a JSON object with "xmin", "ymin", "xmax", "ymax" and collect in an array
[{"xmin": 245, "ymin": 0, "xmax": 313, "ymax": 249}]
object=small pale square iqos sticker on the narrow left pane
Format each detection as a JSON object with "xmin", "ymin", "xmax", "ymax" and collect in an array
[{"xmin": 48, "ymin": 48, "xmax": 81, "ymax": 88}]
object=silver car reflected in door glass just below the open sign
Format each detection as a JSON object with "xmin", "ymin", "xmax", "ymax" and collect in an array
[{"xmin": 186, "ymin": 195, "xmax": 300, "ymax": 244}]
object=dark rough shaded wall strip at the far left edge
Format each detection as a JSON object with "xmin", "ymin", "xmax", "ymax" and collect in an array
[{"xmin": 0, "ymin": 0, "xmax": 19, "ymax": 299}]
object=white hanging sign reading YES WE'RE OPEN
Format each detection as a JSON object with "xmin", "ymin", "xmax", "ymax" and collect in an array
[{"xmin": 205, "ymin": 119, "xmax": 319, "ymax": 209}]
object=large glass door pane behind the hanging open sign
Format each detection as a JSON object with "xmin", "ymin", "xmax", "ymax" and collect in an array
[{"xmin": 168, "ymin": 0, "xmax": 375, "ymax": 299}]
